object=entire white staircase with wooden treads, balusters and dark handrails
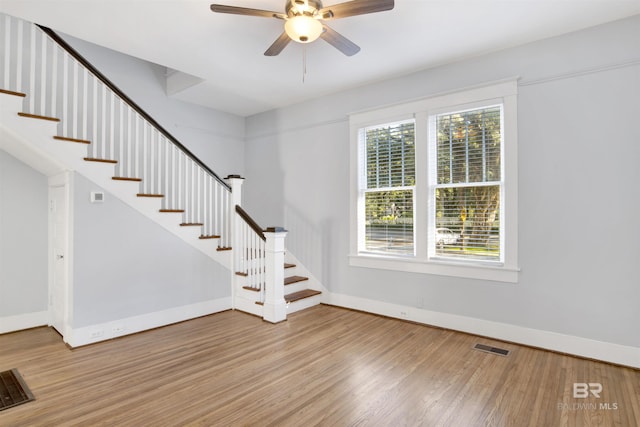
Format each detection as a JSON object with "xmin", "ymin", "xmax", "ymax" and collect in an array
[{"xmin": 0, "ymin": 14, "xmax": 324, "ymax": 345}]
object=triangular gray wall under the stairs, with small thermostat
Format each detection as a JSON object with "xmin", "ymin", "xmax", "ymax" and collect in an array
[{"xmin": 72, "ymin": 174, "xmax": 231, "ymax": 328}]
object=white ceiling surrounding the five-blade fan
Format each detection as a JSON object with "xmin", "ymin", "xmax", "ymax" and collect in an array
[{"xmin": 0, "ymin": 0, "xmax": 640, "ymax": 116}]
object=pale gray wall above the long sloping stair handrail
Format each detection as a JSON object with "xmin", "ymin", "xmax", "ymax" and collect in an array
[{"xmin": 60, "ymin": 34, "xmax": 245, "ymax": 178}]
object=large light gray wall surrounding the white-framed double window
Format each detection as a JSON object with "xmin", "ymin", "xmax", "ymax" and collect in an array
[{"xmin": 244, "ymin": 16, "xmax": 640, "ymax": 347}]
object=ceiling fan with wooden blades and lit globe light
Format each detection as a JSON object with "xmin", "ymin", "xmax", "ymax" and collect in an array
[{"xmin": 211, "ymin": 0, "xmax": 394, "ymax": 56}]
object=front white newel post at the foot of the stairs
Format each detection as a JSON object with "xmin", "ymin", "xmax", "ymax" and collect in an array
[{"xmin": 262, "ymin": 227, "xmax": 287, "ymax": 323}]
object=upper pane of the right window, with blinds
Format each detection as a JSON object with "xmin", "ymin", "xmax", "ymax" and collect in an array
[{"xmin": 436, "ymin": 106, "xmax": 502, "ymax": 184}]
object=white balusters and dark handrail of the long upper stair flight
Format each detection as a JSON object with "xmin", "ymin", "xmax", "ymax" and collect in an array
[{"xmin": 0, "ymin": 14, "xmax": 232, "ymax": 248}]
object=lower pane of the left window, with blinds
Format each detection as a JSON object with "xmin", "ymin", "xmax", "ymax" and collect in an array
[{"xmin": 365, "ymin": 189, "xmax": 414, "ymax": 255}]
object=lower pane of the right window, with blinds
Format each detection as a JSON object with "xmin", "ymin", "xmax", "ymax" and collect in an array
[{"xmin": 435, "ymin": 185, "xmax": 500, "ymax": 261}]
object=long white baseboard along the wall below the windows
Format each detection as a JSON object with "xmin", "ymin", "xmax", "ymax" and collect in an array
[{"xmin": 325, "ymin": 293, "xmax": 640, "ymax": 368}]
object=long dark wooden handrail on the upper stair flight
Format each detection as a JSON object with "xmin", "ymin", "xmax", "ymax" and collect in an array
[{"xmin": 36, "ymin": 24, "xmax": 231, "ymax": 191}]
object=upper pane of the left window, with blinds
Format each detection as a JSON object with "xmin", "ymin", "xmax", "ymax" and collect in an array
[{"xmin": 365, "ymin": 122, "xmax": 415, "ymax": 188}]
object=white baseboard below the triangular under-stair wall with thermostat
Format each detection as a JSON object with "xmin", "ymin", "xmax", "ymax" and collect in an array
[{"xmin": 64, "ymin": 297, "xmax": 231, "ymax": 347}]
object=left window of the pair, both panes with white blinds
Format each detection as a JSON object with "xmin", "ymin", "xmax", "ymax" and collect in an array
[{"xmin": 359, "ymin": 121, "xmax": 416, "ymax": 255}]
